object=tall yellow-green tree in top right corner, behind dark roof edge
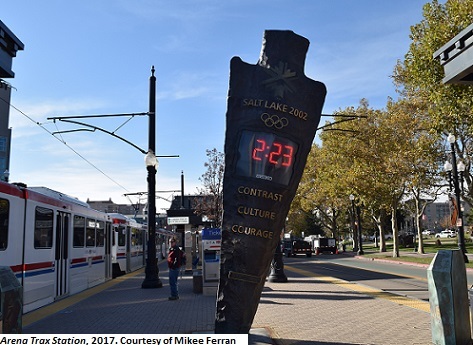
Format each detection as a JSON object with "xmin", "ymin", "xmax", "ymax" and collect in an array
[{"xmin": 393, "ymin": 0, "xmax": 473, "ymax": 205}]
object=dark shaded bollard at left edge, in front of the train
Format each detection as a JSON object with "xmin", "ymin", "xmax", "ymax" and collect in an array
[{"xmin": 0, "ymin": 266, "xmax": 23, "ymax": 334}]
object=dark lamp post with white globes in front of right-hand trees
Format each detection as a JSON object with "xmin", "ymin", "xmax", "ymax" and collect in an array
[{"xmin": 444, "ymin": 133, "xmax": 468, "ymax": 262}]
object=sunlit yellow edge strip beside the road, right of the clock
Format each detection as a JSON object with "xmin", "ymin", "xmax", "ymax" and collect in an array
[{"xmin": 284, "ymin": 265, "xmax": 430, "ymax": 313}]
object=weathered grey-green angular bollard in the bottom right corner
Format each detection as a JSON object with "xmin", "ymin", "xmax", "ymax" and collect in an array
[{"xmin": 427, "ymin": 250, "xmax": 471, "ymax": 345}]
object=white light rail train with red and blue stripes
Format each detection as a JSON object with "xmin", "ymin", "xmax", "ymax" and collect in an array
[{"xmin": 0, "ymin": 181, "xmax": 173, "ymax": 313}]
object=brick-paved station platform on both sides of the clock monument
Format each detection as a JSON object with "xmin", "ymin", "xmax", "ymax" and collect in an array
[{"xmin": 23, "ymin": 263, "xmax": 432, "ymax": 345}]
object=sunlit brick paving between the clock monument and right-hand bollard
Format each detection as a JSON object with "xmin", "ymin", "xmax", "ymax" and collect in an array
[{"xmin": 253, "ymin": 265, "xmax": 432, "ymax": 345}]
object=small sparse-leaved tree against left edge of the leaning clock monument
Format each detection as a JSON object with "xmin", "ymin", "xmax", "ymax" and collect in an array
[{"xmin": 194, "ymin": 148, "xmax": 225, "ymax": 227}]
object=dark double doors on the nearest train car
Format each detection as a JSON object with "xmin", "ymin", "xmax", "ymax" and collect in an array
[{"xmin": 55, "ymin": 211, "xmax": 71, "ymax": 298}]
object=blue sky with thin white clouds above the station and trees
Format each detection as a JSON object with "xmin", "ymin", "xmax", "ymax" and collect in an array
[{"xmin": 0, "ymin": 0, "xmax": 427, "ymax": 212}]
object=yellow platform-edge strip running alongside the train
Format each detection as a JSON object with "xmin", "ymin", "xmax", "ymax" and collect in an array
[{"xmin": 22, "ymin": 268, "xmax": 144, "ymax": 327}]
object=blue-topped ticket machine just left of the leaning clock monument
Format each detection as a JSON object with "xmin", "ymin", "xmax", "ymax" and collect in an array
[{"xmin": 201, "ymin": 228, "xmax": 222, "ymax": 295}]
